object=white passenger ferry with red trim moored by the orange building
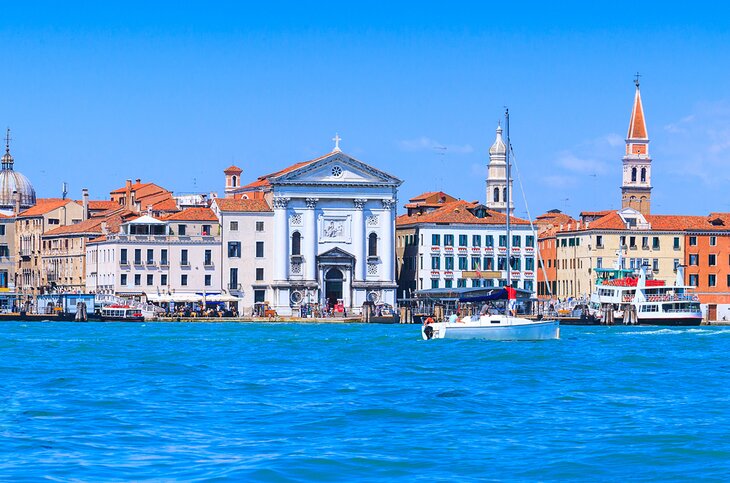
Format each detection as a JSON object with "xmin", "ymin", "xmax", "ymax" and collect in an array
[{"xmin": 590, "ymin": 258, "xmax": 702, "ymax": 325}]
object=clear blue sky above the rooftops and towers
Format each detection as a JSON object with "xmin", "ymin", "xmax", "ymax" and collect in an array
[{"xmin": 0, "ymin": 1, "xmax": 730, "ymax": 216}]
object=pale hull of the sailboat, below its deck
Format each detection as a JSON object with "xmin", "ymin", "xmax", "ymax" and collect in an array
[{"xmin": 421, "ymin": 320, "xmax": 560, "ymax": 341}]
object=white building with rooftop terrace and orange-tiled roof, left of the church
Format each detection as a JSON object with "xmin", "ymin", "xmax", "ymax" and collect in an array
[{"xmin": 86, "ymin": 208, "xmax": 221, "ymax": 297}]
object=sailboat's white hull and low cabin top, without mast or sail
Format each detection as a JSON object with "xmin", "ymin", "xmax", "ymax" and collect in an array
[{"xmin": 421, "ymin": 314, "xmax": 560, "ymax": 341}]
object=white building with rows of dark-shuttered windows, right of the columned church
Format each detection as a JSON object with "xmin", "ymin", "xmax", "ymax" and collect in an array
[{"xmin": 396, "ymin": 195, "xmax": 537, "ymax": 297}]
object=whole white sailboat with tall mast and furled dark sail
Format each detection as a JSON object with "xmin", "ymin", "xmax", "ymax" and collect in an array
[{"xmin": 421, "ymin": 111, "xmax": 560, "ymax": 341}]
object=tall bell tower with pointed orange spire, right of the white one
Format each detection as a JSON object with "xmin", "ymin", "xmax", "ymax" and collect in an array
[{"xmin": 621, "ymin": 73, "xmax": 651, "ymax": 215}]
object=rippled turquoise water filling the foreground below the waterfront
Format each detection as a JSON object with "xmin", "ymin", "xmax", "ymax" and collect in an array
[{"xmin": 0, "ymin": 323, "xmax": 730, "ymax": 481}]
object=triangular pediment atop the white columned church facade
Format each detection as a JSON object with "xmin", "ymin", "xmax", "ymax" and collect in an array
[{"xmin": 270, "ymin": 152, "xmax": 402, "ymax": 186}]
